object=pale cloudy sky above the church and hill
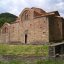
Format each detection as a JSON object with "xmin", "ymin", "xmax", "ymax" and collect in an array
[{"xmin": 0, "ymin": 0, "xmax": 64, "ymax": 17}]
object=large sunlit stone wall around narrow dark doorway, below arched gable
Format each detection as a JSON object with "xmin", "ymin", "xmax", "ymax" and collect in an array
[{"xmin": 20, "ymin": 17, "xmax": 49, "ymax": 44}]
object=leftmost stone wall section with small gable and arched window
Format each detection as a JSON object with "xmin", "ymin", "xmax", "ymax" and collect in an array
[{"xmin": 0, "ymin": 23, "xmax": 10, "ymax": 43}]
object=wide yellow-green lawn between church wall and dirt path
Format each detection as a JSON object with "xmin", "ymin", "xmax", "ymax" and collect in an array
[{"xmin": 0, "ymin": 44, "xmax": 48, "ymax": 56}]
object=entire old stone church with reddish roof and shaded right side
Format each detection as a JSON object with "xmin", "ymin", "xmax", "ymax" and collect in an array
[{"xmin": 0, "ymin": 7, "xmax": 64, "ymax": 44}]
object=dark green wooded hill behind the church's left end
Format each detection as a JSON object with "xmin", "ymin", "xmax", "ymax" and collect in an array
[{"xmin": 0, "ymin": 13, "xmax": 17, "ymax": 27}]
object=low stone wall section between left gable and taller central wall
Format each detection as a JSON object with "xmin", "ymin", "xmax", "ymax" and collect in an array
[{"xmin": 10, "ymin": 23, "xmax": 20, "ymax": 43}]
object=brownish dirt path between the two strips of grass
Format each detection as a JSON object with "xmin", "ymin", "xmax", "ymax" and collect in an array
[{"xmin": 0, "ymin": 55, "xmax": 46, "ymax": 61}]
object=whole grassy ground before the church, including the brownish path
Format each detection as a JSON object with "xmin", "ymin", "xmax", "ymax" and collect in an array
[{"xmin": 0, "ymin": 44, "xmax": 64, "ymax": 64}]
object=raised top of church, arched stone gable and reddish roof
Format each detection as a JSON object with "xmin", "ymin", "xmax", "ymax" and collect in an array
[{"xmin": 19, "ymin": 7, "xmax": 46, "ymax": 21}]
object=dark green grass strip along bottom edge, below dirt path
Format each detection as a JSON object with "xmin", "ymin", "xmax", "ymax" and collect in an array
[{"xmin": 0, "ymin": 60, "xmax": 64, "ymax": 64}]
